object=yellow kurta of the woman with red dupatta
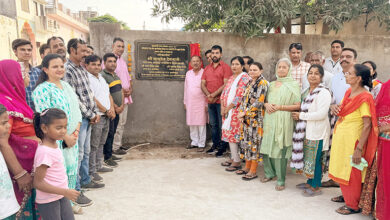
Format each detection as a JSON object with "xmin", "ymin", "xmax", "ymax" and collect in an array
[{"xmin": 329, "ymin": 102, "xmax": 371, "ymax": 184}]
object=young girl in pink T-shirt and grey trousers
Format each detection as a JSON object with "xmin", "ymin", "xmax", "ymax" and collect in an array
[{"xmin": 34, "ymin": 108, "xmax": 80, "ymax": 220}]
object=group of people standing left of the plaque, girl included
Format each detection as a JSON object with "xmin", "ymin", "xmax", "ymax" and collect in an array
[{"xmin": 0, "ymin": 36, "xmax": 133, "ymax": 220}]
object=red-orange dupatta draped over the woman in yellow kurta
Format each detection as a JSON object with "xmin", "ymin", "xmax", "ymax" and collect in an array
[{"xmin": 335, "ymin": 88, "xmax": 378, "ymax": 167}]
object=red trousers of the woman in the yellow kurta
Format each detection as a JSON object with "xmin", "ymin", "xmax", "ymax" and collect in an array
[{"xmin": 340, "ymin": 167, "xmax": 362, "ymax": 210}]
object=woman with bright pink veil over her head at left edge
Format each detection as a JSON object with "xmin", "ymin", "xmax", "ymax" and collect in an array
[{"xmin": 0, "ymin": 60, "xmax": 39, "ymax": 219}]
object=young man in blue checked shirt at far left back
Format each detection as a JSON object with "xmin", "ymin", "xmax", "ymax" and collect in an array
[{"xmin": 12, "ymin": 39, "xmax": 41, "ymax": 111}]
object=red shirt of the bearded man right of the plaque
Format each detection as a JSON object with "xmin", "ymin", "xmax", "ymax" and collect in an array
[{"xmin": 202, "ymin": 60, "xmax": 233, "ymax": 103}]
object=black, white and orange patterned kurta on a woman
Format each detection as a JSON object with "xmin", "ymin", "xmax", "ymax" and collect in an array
[{"xmin": 240, "ymin": 76, "xmax": 269, "ymax": 160}]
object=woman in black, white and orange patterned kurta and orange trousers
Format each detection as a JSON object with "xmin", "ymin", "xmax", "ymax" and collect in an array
[{"xmin": 236, "ymin": 62, "xmax": 269, "ymax": 180}]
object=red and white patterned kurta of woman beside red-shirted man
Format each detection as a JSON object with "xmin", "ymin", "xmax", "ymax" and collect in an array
[{"xmin": 221, "ymin": 73, "xmax": 250, "ymax": 143}]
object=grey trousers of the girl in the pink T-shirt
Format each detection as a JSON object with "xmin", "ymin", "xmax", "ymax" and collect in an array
[{"xmin": 37, "ymin": 197, "xmax": 74, "ymax": 220}]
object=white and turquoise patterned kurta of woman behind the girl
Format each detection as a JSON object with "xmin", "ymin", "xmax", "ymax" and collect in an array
[{"xmin": 33, "ymin": 81, "xmax": 82, "ymax": 189}]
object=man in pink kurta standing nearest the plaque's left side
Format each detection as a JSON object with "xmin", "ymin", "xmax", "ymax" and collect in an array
[{"xmin": 112, "ymin": 37, "xmax": 133, "ymax": 155}]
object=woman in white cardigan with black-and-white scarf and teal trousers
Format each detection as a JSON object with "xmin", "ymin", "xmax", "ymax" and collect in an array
[{"xmin": 291, "ymin": 64, "xmax": 332, "ymax": 197}]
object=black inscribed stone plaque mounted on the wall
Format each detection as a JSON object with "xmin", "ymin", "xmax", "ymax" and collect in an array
[{"xmin": 135, "ymin": 41, "xmax": 190, "ymax": 80}]
